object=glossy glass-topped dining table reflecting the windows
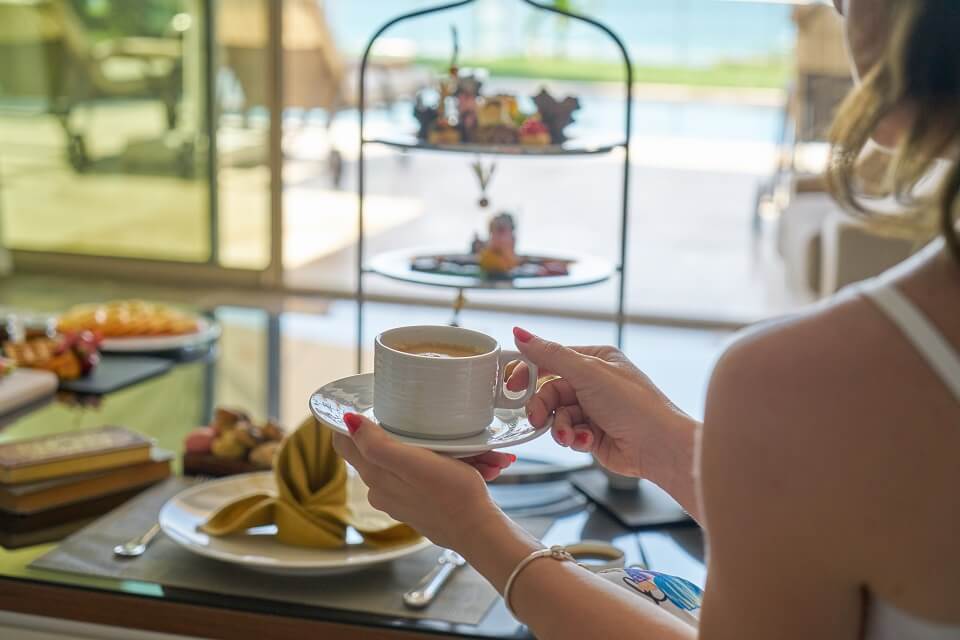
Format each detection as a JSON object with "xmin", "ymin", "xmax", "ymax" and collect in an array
[{"xmin": 0, "ymin": 303, "xmax": 705, "ymax": 640}]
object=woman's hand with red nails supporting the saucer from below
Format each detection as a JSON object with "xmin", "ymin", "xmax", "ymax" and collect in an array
[{"xmin": 333, "ymin": 413, "xmax": 516, "ymax": 548}]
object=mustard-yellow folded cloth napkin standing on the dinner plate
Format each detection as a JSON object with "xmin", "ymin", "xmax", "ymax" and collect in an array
[{"xmin": 200, "ymin": 418, "xmax": 420, "ymax": 548}]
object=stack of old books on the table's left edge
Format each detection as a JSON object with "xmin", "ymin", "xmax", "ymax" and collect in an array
[{"xmin": 0, "ymin": 427, "xmax": 173, "ymax": 549}]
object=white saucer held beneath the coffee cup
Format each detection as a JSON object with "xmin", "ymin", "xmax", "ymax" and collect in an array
[{"xmin": 310, "ymin": 373, "xmax": 552, "ymax": 458}]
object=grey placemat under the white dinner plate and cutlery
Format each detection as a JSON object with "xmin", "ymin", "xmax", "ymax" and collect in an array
[{"xmin": 30, "ymin": 478, "xmax": 552, "ymax": 625}]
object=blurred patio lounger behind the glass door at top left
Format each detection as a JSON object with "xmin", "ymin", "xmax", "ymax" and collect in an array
[{"xmin": 0, "ymin": 0, "xmax": 183, "ymax": 171}]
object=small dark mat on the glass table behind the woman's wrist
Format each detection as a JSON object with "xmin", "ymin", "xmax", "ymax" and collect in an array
[{"xmin": 570, "ymin": 469, "xmax": 693, "ymax": 529}]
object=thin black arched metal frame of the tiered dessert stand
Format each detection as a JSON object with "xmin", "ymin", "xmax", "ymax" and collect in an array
[{"xmin": 356, "ymin": 0, "xmax": 633, "ymax": 373}]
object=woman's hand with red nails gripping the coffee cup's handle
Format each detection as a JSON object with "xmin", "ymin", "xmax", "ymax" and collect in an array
[{"xmin": 507, "ymin": 328, "xmax": 698, "ymax": 506}]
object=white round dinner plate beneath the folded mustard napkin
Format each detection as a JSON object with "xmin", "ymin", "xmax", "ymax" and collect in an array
[{"xmin": 160, "ymin": 471, "xmax": 432, "ymax": 576}]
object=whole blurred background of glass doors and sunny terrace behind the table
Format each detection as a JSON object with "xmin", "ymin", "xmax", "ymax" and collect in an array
[{"xmin": 0, "ymin": 0, "xmax": 892, "ymax": 326}]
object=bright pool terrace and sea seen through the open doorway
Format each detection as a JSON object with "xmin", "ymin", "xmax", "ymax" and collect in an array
[{"xmin": 287, "ymin": 0, "xmax": 802, "ymax": 319}]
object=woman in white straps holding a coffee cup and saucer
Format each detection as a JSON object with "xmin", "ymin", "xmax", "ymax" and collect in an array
[{"xmin": 336, "ymin": 0, "xmax": 960, "ymax": 640}]
